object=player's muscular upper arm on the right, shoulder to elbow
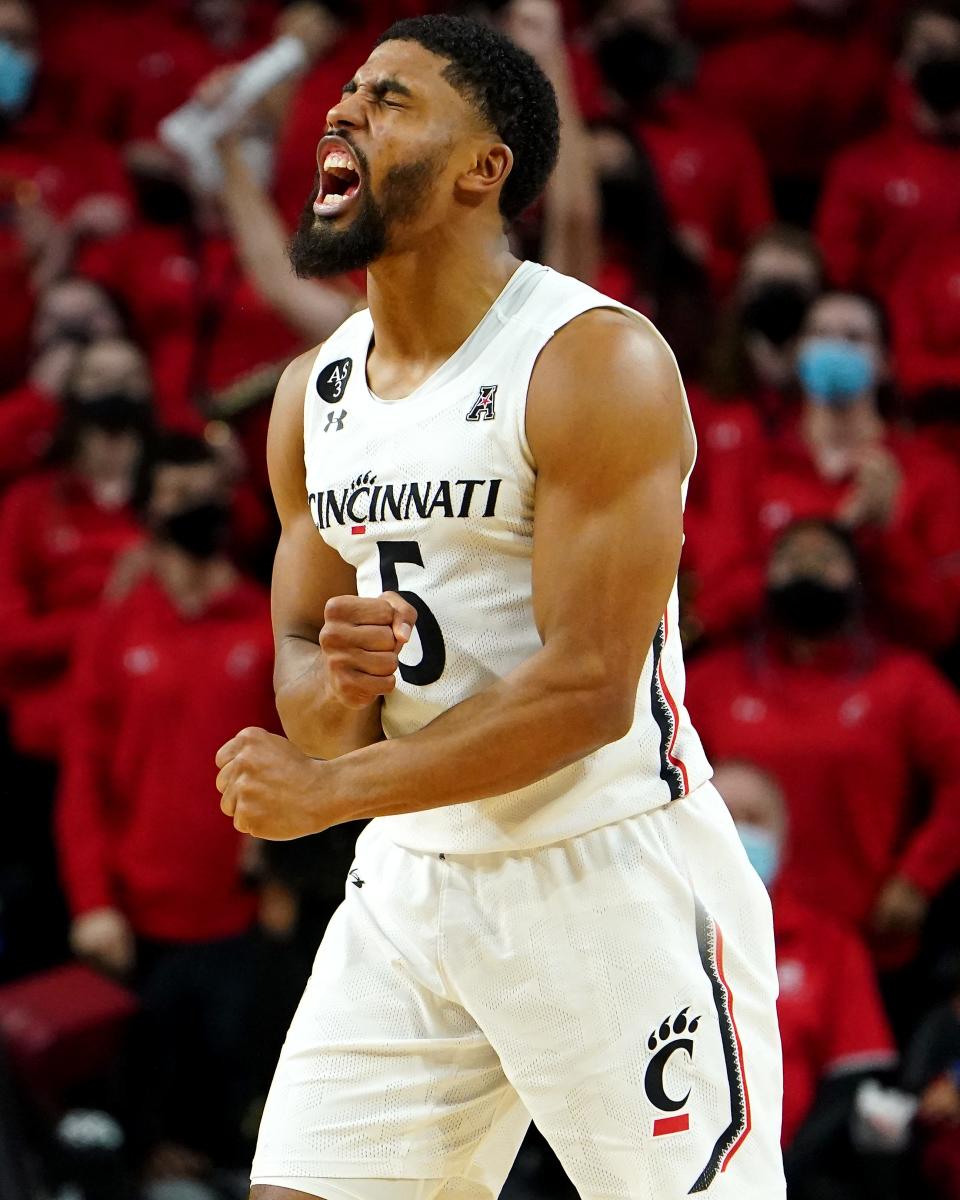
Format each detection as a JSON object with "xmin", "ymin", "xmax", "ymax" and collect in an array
[{"xmin": 527, "ymin": 312, "xmax": 692, "ymax": 698}]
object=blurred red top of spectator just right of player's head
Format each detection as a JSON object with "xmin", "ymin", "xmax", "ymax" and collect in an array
[{"xmin": 634, "ymin": 91, "xmax": 773, "ymax": 292}]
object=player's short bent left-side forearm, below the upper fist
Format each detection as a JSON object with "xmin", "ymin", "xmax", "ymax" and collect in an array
[{"xmin": 274, "ymin": 638, "xmax": 383, "ymax": 758}]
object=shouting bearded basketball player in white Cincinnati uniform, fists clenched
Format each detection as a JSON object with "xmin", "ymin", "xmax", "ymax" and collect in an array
[{"xmin": 217, "ymin": 16, "xmax": 784, "ymax": 1200}]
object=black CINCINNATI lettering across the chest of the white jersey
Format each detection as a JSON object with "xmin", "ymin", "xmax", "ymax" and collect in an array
[{"xmin": 307, "ymin": 472, "xmax": 503, "ymax": 529}]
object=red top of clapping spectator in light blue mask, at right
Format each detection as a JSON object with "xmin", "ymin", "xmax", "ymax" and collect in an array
[{"xmin": 754, "ymin": 430, "xmax": 960, "ymax": 649}]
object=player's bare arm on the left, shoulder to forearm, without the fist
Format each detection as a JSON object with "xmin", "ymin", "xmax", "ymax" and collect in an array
[{"xmin": 266, "ymin": 350, "xmax": 383, "ymax": 758}]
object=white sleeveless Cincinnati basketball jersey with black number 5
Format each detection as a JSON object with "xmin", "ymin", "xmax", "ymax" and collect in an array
[{"xmin": 304, "ymin": 263, "xmax": 710, "ymax": 853}]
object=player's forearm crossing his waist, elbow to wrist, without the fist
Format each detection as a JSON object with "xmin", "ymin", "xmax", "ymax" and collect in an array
[{"xmin": 319, "ymin": 649, "xmax": 634, "ymax": 820}]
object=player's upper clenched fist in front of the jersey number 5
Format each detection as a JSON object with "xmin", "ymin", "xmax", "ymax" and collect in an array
[{"xmin": 319, "ymin": 592, "xmax": 416, "ymax": 708}]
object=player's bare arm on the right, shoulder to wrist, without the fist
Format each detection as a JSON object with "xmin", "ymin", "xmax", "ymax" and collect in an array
[{"xmin": 318, "ymin": 311, "xmax": 692, "ymax": 824}]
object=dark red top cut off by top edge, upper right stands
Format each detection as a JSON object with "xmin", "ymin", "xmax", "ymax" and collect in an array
[{"xmin": 680, "ymin": 0, "xmax": 899, "ymax": 175}]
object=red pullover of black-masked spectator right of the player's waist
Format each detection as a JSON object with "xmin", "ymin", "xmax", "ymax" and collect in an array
[{"xmin": 686, "ymin": 637, "xmax": 960, "ymax": 924}]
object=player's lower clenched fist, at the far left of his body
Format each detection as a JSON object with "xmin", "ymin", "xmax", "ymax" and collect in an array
[{"xmin": 216, "ymin": 728, "xmax": 336, "ymax": 841}]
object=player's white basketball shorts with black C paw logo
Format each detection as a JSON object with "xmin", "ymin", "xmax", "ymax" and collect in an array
[{"xmin": 252, "ymin": 784, "xmax": 785, "ymax": 1200}]
